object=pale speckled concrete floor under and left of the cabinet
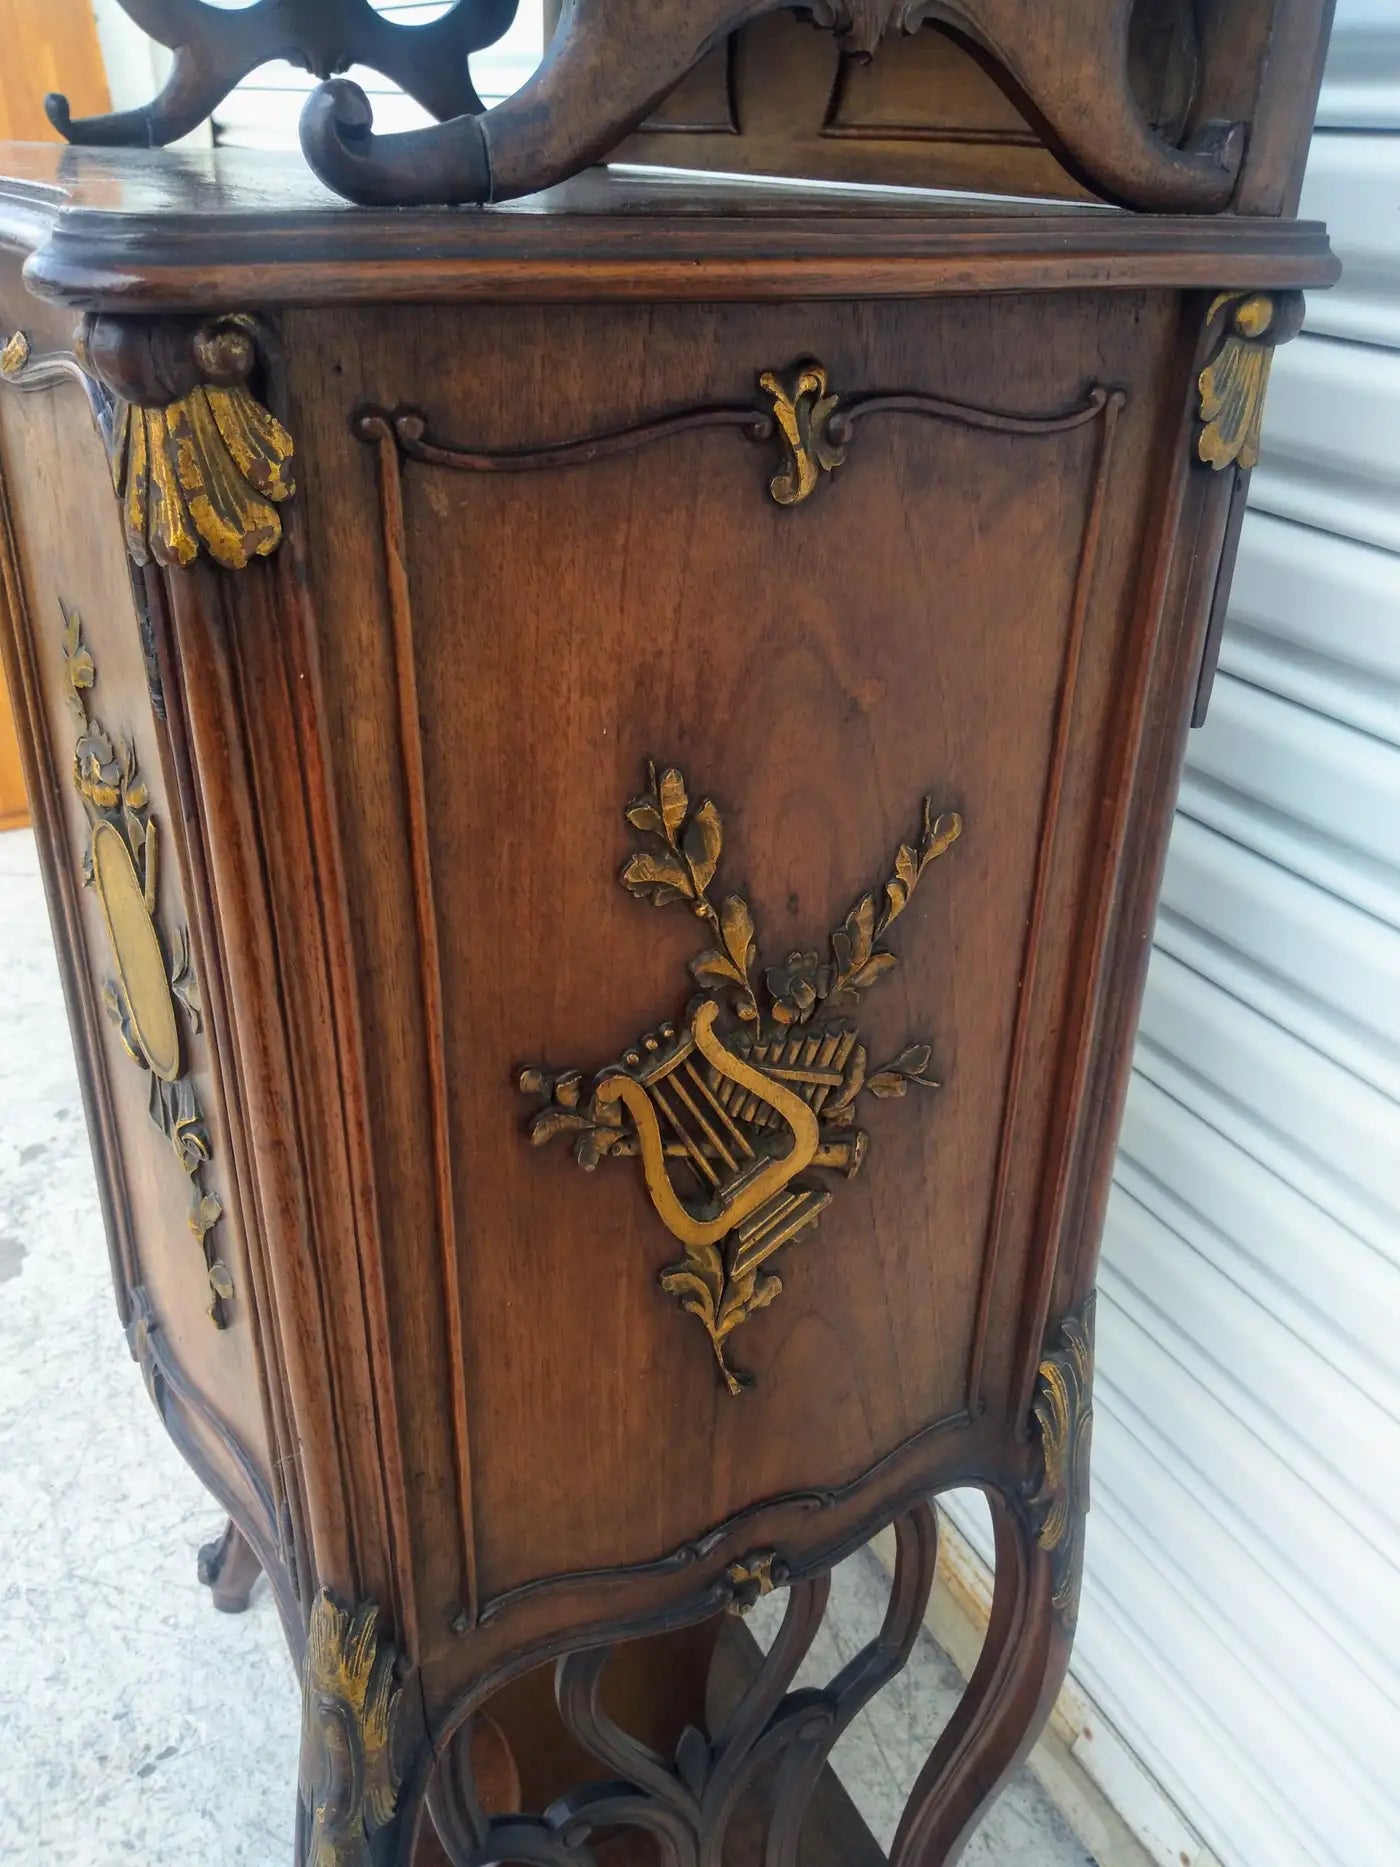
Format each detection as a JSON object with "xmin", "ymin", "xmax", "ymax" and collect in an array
[{"xmin": 0, "ymin": 831, "xmax": 1094, "ymax": 1867}]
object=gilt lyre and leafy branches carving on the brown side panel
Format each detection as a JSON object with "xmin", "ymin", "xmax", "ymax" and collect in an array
[{"xmin": 519, "ymin": 765, "xmax": 963, "ymax": 1395}]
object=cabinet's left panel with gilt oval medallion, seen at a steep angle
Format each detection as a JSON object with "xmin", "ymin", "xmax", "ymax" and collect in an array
[{"xmin": 0, "ymin": 286, "xmax": 284, "ymax": 1598}]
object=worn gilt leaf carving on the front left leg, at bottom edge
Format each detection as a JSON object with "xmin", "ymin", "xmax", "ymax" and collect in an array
[{"xmin": 301, "ymin": 1589, "xmax": 401, "ymax": 1867}]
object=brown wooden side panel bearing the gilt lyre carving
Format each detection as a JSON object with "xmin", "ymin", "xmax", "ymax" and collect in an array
[{"xmin": 286, "ymin": 293, "xmax": 1182, "ymax": 1657}]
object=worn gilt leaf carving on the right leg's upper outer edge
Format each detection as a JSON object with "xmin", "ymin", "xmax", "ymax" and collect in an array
[{"xmin": 1030, "ymin": 1294, "xmax": 1094, "ymax": 1628}]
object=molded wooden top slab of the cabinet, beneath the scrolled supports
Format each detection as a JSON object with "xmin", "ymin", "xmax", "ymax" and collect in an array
[{"xmin": 0, "ymin": 144, "xmax": 1338, "ymax": 312}]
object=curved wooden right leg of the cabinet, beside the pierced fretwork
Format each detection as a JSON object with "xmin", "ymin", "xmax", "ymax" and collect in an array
[{"xmin": 890, "ymin": 1495, "xmax": 1073, "ymax": 1867}]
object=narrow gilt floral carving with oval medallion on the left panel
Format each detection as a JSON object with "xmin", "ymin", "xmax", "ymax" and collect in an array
[{"xmin": 63, "ymin": 609, "xmax": 233, "ymax": 1329}]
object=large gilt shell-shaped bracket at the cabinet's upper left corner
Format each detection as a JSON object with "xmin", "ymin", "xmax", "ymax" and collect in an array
[{"xmin": 78, "ymin": 316, "xmax": 295, "ymax": 569}]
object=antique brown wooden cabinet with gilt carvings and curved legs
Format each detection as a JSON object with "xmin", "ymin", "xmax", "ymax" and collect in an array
[{"xmin": 0, "ymin": 0, "xmax": 1335, "ymax": 1867}]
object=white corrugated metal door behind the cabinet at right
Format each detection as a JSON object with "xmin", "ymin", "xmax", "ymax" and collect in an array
[{"xmin": 1052, "ymin": 0, "xmax": 1400, "ymax": 1867}]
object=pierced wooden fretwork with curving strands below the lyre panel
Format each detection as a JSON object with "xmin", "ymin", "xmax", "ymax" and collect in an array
[{"xmin": 433, "ymin": 1503, "xmax": 937, "ymax": 1867}]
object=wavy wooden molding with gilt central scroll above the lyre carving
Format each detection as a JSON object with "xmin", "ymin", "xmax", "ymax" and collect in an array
[{"xmin": 351, "ymin": 358, "xmax": 1120, "ymax": 506}]
